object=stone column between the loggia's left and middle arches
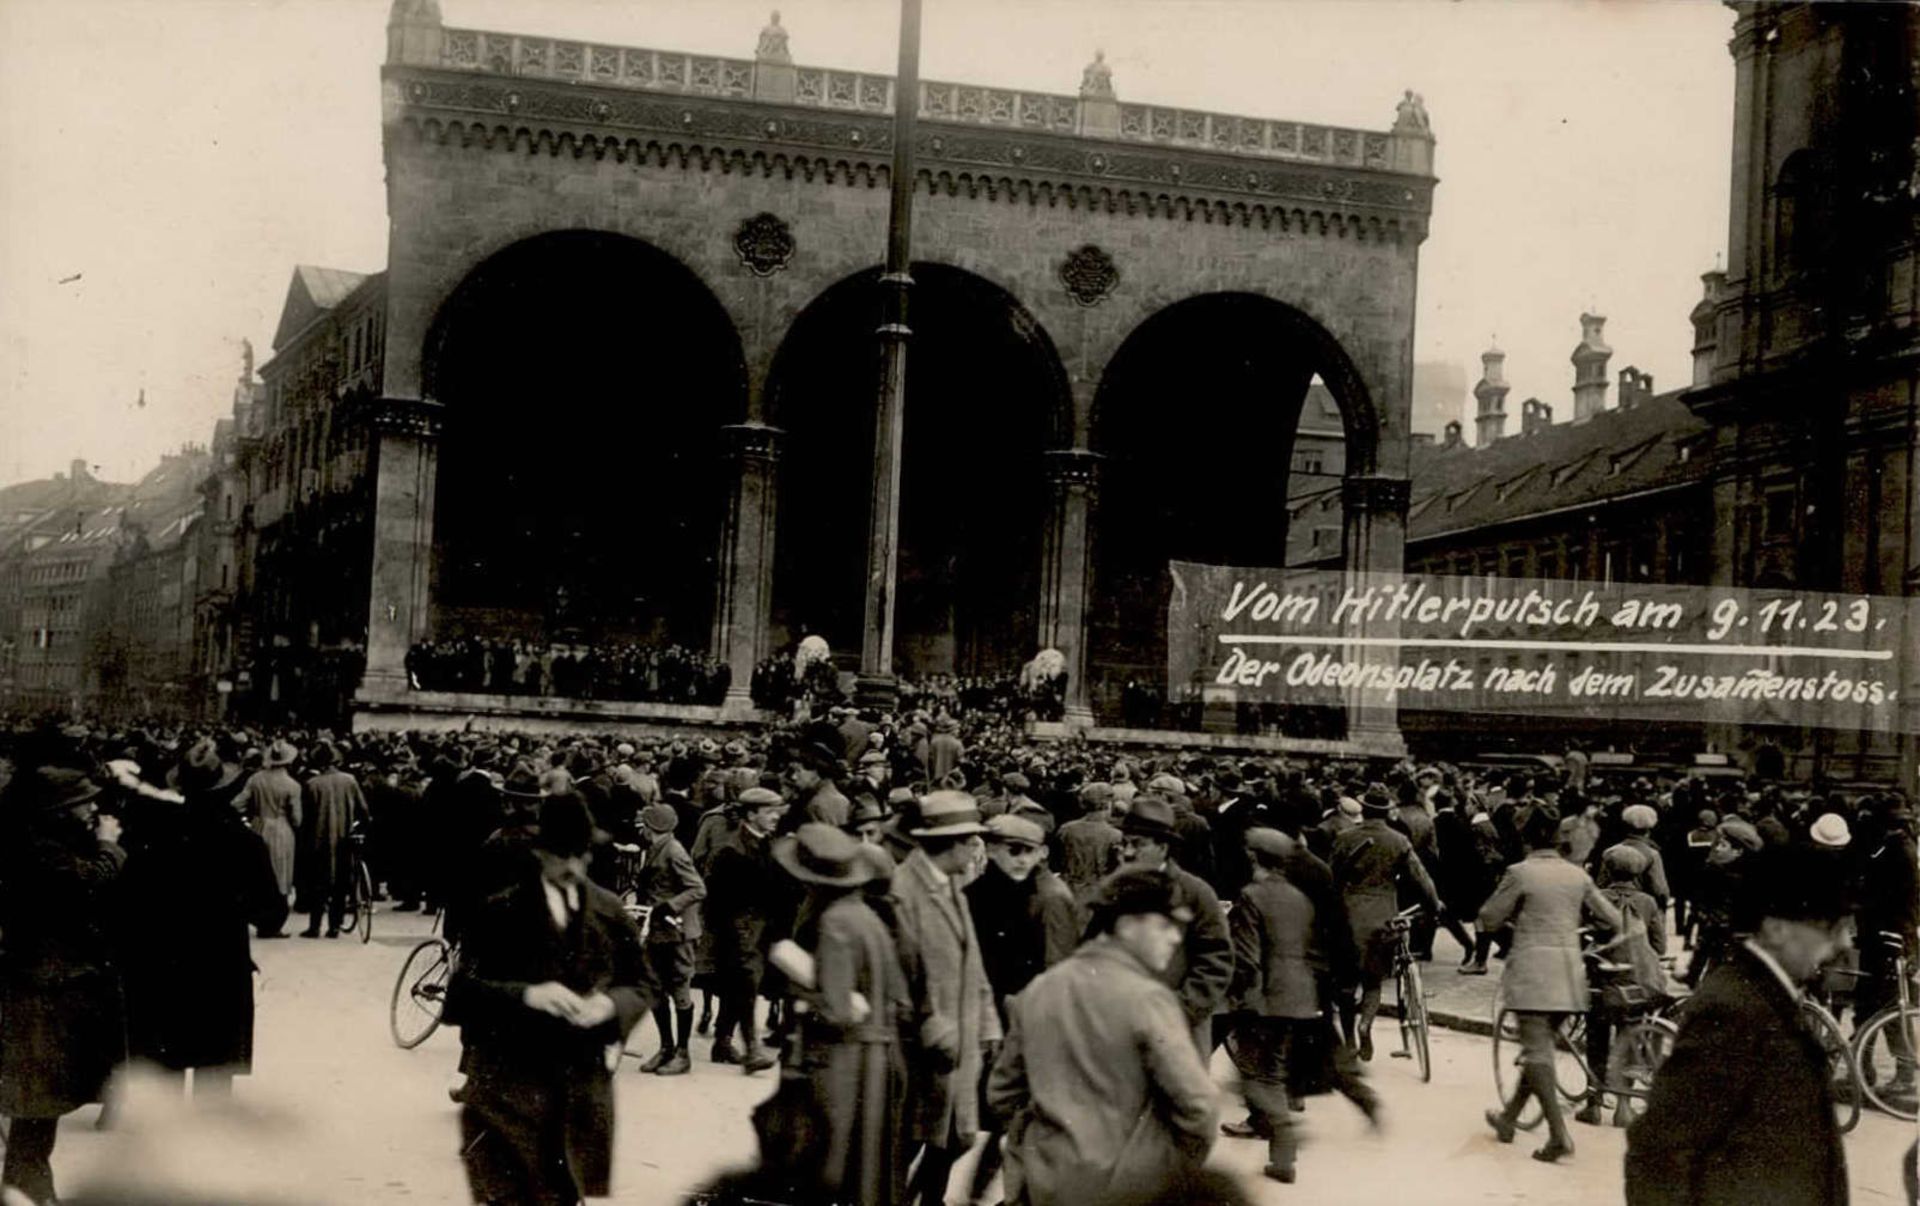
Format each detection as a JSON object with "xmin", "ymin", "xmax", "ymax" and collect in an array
[{"xmin": 712, "ymin": 422, "xmax": 785, "ymax": 716}]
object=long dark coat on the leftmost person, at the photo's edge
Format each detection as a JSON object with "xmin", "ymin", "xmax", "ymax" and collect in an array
[{"xmin": 0, "ymin": 818, "xmax": 127, "ymax": 1118}]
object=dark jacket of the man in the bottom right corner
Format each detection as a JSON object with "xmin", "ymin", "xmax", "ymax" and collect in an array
[{"xmin": 1626, "ymin": 947, "xmax": 1847, "ymax": 1206}]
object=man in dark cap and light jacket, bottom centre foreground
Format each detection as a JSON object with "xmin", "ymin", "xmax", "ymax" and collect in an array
[{"xmin": 987, "ymin": 871, "xmax": 1219, "ymax": 1206}]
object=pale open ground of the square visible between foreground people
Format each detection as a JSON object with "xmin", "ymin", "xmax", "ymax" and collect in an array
[{"xmin": 30, "ymin": 912, "xmax": 1914, "ymax": 1206}]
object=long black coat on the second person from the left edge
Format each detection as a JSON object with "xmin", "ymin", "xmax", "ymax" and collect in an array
[{"xmin": 119, "ymin": 791, "xmax": 286, "ymax": 1072}]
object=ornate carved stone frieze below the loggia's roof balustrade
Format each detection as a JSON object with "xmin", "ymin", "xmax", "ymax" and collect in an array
[{"xmin": 388, "ymin": 68, "xmax": 1432, "ymax": 236}]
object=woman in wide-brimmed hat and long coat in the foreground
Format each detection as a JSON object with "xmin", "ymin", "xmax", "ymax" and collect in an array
[{"xmin": 755, "ymin": 824, "xmax": 912, "ymax": 1206}]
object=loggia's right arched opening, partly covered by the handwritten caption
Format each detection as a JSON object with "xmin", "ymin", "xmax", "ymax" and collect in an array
[{"xmin": 1087, "ymin": 294, "xmax": 1379, "ymax": 736}]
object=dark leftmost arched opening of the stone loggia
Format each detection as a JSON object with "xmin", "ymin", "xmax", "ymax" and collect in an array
[{"xmin": 422, "ymin": 230, "xmax": 745, "ymax": 649}]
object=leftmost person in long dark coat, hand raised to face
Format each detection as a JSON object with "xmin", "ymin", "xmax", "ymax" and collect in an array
[{"xmin": 0, "ymin": 768, "xmax": 127, "ymax": 1202}]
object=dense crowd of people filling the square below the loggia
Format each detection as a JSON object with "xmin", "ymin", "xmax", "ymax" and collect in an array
[{"xmin": 0, "ymin": 706, "xmax": 1916, "ymax": 1206}]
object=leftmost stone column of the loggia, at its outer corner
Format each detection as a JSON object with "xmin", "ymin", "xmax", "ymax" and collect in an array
[{"xmin": 359, "ymin": 398, "xmax": 442, "ymax": 699}]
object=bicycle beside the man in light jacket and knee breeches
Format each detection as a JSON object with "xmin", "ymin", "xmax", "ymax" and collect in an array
[{"xmin": 1494, "ymin": 947, "xmax": 1680, "ymax": 1131}]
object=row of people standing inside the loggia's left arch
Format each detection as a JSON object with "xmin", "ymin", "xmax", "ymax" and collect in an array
[{"xmin": 407, "ymin": 636, "xmax": 732, "ymax": 705}]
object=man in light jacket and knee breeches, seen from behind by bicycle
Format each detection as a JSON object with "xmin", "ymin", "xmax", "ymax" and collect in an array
[{"xmin": 1478, "ymin": 805, "xmax": 1620, "ymax": 1164}]
